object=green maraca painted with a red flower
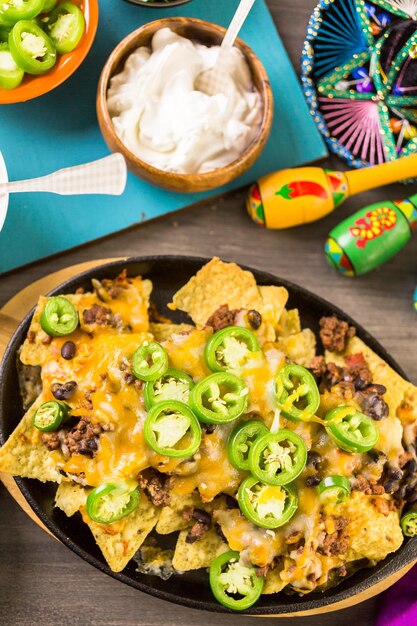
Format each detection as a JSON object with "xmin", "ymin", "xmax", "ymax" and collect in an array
[{"xmin": 325, "ymin": 194, "xmax": 417, "ymax": 276}]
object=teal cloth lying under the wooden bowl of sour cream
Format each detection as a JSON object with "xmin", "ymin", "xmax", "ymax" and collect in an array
[{"xmin": 0, "ymin": 0, "xmax": 326, "ymax": 273}]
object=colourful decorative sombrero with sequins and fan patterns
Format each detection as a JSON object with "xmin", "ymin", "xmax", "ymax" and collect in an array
[{"xmin": 302, "ymin": 0, "xmax": 417, "ymax": 167}]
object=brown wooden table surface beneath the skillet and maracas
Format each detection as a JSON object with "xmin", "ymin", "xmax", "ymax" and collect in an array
[{"xmin": 0, "ymin": 0, "xmax": 417, "ymax": 626}]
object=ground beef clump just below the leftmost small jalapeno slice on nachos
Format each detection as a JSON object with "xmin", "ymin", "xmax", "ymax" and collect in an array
[{"xmin": 42, "ymin": 416, "xmax": 103, "ymax": 458}]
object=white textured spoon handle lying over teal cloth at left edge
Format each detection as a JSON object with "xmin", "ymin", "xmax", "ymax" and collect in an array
[{"xmin": 0, "ymin": 153, "xmax": 127, "ymax": 196}]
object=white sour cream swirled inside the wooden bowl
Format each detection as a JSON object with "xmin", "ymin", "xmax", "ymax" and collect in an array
[{"xmin": 107, "ymin": 28, "xmax": 262, "ymax": 174}]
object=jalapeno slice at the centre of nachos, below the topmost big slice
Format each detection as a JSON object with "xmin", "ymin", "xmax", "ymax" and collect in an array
[{"xmin": 190, "ymin": 372, "xmax": 249, "ymax": 424}]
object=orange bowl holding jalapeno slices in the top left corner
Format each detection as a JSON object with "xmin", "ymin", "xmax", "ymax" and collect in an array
[{"xmin": 0, "ymin": 0, "xmax": 98, "ymax": 104}]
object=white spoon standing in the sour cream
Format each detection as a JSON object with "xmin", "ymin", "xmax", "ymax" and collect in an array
[{"xmin": 195, "ymin": 0, "xmax": 255, "ymax": 96}]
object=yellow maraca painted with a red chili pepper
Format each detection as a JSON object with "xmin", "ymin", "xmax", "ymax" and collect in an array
[{"xmin": 246, "ymin": 154, "xmax": 417, "ymax": 228}]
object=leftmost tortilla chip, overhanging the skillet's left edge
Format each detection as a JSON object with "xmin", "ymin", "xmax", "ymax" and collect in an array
[{"xmin": 0, "ymin": 395, "xmax": 61, "ymax": 483}]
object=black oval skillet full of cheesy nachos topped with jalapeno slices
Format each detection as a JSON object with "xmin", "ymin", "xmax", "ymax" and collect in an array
[{"xmin": 0, "ymin": 257, "xmax": 417, "ymax": 615}]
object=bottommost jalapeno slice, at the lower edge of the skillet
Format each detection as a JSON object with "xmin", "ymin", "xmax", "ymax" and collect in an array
[{"xmin": 210, "ymin": 551, "xmax": 264, "ymax": 611}]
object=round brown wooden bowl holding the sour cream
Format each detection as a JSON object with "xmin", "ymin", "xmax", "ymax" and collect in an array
[{"xmin": 97, "ymin": 17, "xmax": 273, "ymax": 193}]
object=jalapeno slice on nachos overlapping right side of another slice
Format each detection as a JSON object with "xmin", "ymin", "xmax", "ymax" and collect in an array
[{"xmin": 249, "ymin": 428, "xmax": 307, "ymax": 485}]
